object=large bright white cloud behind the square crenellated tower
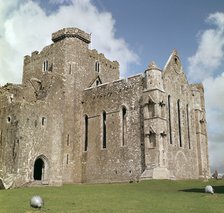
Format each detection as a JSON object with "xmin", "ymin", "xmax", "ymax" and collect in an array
[{"xmin": 0, "ymin": 0, "xmax": 138, "ymax": 85}]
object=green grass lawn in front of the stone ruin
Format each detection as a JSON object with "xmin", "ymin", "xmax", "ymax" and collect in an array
[{"xmin": 0, "ymin": 180, "xmax": 224, "ymax": 213}]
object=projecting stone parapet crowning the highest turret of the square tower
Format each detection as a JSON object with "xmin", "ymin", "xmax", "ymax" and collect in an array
[{"xmin": 51, "ymin": 28, "xmax": 91, "ymax": 44}]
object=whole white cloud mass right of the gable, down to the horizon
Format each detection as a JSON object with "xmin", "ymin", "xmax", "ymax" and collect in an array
[{"xmin": 189, "ymin": 12, "xmax": 224, "ymax": 172}]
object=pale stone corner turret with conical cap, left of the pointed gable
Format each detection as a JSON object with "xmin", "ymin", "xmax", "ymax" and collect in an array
[{"xmin": 141, "ymin": 62, "xmax": 169, "ymax": 179}]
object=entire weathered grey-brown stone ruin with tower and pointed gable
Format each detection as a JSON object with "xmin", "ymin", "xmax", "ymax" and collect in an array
[{"xmin": 0, "ymin": 28, "xmax": 210, "ymax": 188}]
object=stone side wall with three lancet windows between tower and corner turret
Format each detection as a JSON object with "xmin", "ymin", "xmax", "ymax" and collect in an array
[{"xmin": 82, "ymin": 75, "xmax": 143, "ymax": 182}]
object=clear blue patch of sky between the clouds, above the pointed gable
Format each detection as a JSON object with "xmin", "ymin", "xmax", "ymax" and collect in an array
[{"xmin": 93, "ymin": 0, "xmax": 224, "ymax": 76}]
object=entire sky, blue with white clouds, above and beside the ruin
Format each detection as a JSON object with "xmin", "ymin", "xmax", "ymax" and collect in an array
[{"xmin": 0, "ymin": 0, "xmax": 224, "ymax": 172}]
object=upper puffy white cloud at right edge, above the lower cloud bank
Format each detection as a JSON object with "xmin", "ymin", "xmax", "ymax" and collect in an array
[{"xmin": 189, "ymin": 13, "xmax": 224, "ymax": 81}]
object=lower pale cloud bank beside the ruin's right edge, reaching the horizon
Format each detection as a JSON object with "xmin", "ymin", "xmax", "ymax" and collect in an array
[{"xmin": 203, "ymin": 72, "xmax": 224, "ymax": 172}]
